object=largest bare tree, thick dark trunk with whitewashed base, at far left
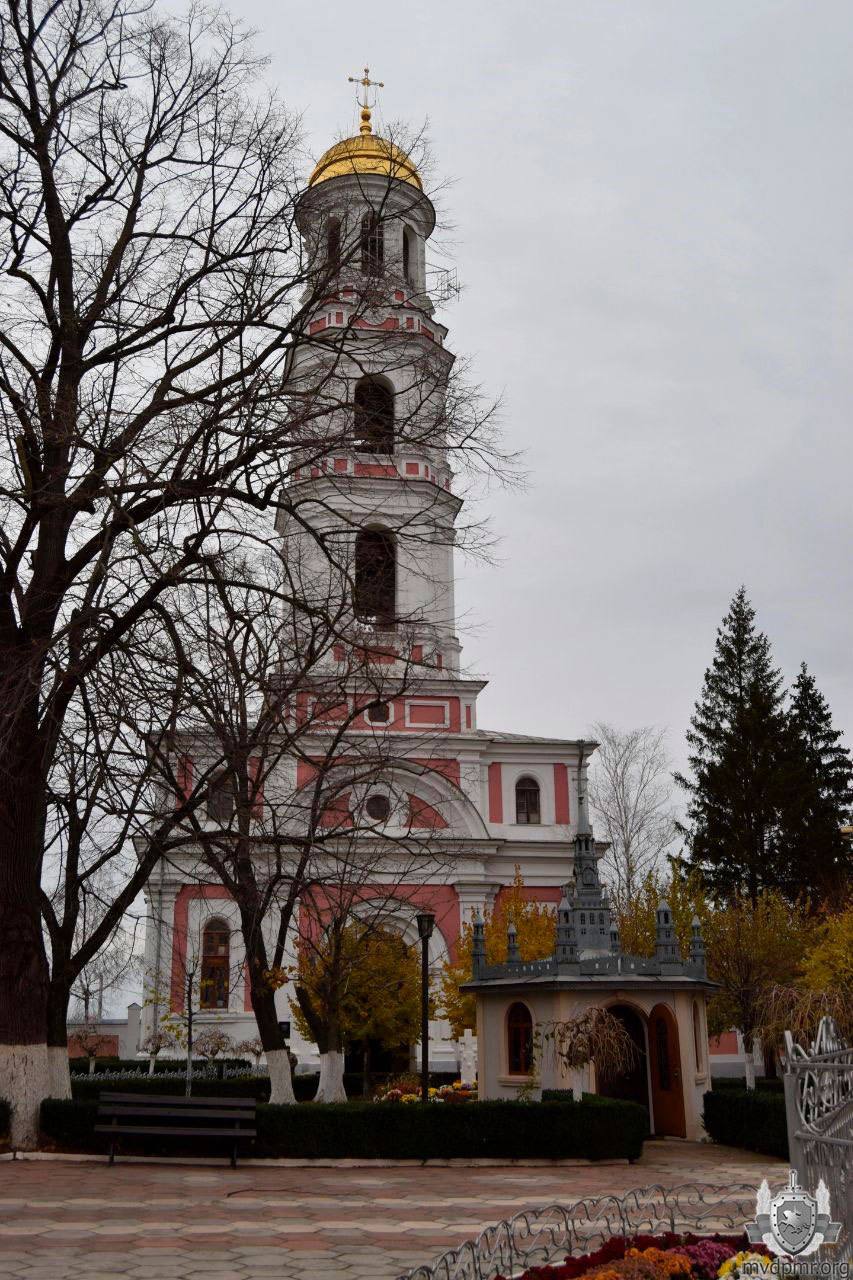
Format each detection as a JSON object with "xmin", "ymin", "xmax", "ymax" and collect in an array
[{"xmin": 0, "ymin": 0, "xmax": 494, "ymax": 1146}]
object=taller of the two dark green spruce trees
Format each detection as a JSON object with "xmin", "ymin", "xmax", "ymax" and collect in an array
[{"xmin": 675, "ymin": 586, "xmax": 786, "ymax": 904}]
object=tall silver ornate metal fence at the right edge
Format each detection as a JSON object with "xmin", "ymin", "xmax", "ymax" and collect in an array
[{"xmin": 785, "ymin": 1018, "xmax": 853, "ymax": 1262}]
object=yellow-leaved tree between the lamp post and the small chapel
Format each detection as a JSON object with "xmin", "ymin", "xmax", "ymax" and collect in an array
[{"xmin": 438, "ymin": 865, "xmax": 557, "ymax": 1039}]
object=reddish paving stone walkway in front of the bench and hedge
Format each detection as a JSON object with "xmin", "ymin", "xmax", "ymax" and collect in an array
[{"xmin": 0, "ymin": 1142, "xmax": 784, "ymax": 1280}]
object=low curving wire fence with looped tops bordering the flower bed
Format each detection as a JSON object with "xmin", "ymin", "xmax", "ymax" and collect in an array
[{"xmin": 400, "ymin": 1183, "xmax": 756, "ymax": 1280}]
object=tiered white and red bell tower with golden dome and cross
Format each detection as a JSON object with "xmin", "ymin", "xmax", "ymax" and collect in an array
[{"xmin": 279, "ymin": 68, "xmax": 476, "ymax": 701}]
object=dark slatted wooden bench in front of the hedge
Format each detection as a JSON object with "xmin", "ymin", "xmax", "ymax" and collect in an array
[{"xmin": 95, "ymin": 1093, "xmax": 257, "ymax": 1169}]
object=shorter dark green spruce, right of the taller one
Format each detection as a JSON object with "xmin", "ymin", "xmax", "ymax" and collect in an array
[{"xmin": 775, "ymin": 663, "xmax": 853, "ymax": 904}]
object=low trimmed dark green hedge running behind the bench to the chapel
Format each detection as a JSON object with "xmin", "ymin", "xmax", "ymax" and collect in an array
[{"xmin": 41, "ymin": 1098, "xmax": 647, "ymax": 1160}]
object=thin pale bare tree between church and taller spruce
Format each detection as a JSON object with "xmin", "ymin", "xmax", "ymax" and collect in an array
[{"xmin": 589, "ymin": 722, "xmax": 675, "ymax": 910}]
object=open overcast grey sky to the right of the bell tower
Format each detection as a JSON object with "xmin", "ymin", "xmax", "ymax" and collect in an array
[{"xmin": 216, "ymin": 0, "xmax": 853, "ymax": 758}]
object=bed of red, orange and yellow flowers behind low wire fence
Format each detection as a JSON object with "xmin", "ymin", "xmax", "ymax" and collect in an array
[{"xmin": 497, "ymin": 1231, "xmax": 771, "ymax": 1280}]
